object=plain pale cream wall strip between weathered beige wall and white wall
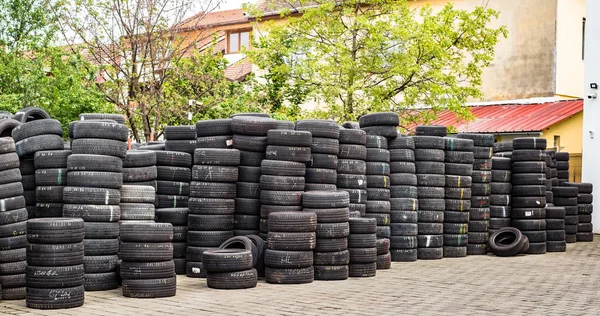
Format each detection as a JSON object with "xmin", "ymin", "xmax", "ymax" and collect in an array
[{"xmin": 556, "ymin": 0, "xmax": 592, "ymax": 98}]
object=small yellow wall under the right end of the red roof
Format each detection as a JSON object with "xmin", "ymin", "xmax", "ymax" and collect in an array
[{"xmin": 541, "ymin": 112, "xmax": 583, "ymax": 154}]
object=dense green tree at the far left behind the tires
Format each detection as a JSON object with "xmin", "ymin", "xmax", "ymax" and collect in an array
[{"xmin": 0, "ymin": 0, "xmax": 115, "ymax": 132}]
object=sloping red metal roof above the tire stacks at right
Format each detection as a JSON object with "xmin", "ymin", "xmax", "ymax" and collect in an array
[{"xmin": 428, "ymin": 100, "xmax": 583, "ymax": 133}]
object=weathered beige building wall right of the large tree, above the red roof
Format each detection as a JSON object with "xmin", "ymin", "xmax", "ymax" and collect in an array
[{"xmin": 415, "ymin": 0, "xmax": 556, "ymax": 101}]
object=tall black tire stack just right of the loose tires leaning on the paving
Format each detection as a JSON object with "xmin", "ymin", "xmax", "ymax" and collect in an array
[{"xmin": 511, "ymin": 137, "xmax": 548, "ymax": 254}]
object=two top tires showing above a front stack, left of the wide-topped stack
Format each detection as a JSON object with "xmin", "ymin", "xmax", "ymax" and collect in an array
[{"xmin": 196, "ymin": 119, "xmax": 233, "ymax": 148}]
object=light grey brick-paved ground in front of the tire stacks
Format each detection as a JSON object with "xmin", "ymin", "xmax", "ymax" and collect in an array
[{"xmin": 0, "ymin": 238, "xmax": 600, "ymax": 316}]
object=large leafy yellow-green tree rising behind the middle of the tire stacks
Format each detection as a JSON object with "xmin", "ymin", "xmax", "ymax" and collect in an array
[{"xmin": 249, "ymin": 0, "xmax": 507, "ymax": 127}]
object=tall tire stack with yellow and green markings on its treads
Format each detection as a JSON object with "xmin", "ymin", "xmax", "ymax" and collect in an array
[{"xmin": 444, "ymin": 137, "xmax": 475, "ymax": 258}]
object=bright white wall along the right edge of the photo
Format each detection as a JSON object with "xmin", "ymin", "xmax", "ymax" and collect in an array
[{"xmin": 582, "ymin": 0, "xmax": 600, "ymax": 233}]
